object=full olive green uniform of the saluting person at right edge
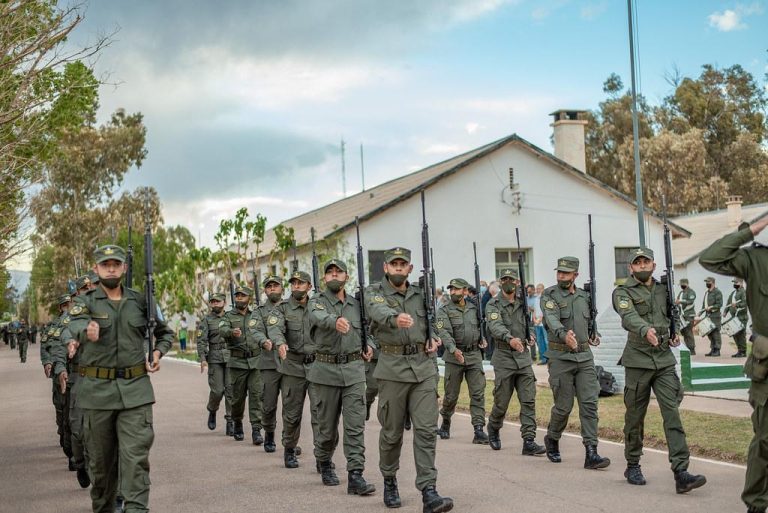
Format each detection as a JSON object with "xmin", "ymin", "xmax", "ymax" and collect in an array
[{"xmin": 699, "ymin": 227, "xmax": 768, "ymax": 510}]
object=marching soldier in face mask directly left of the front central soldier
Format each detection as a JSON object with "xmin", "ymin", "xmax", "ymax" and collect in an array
[{"xmin": 307, "ymin": 259, "xmax": 376, "ymax": 495}]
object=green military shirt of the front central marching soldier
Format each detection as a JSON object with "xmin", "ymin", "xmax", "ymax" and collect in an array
[{"xmin": 365, "ymin": 280, "xmax": 437, "ymax": 383}]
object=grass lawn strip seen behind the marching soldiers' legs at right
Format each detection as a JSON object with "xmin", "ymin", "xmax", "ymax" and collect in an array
[{"xmin": 438, "ymin": 379, "xmax": 752, "ymax": 463}]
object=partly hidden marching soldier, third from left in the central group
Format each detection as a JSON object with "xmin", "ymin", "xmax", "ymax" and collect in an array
[{"xmin": 256, "ymin": 276, "xmax": 283, "ymax": 452}]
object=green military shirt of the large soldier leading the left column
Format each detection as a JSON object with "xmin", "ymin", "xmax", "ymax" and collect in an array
[{"xmin": 69, "ymin": 287, "xmax": 173, "ymax": 410}]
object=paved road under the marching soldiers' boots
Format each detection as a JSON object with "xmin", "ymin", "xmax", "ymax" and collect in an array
[{"xmin": 0, "ymin": 345, "xmax": 745, "ymax": 513}]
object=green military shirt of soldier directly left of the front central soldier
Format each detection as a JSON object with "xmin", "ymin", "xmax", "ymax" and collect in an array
[{"xmin": 307, "ymin": 289, "xmax": 365, "ymax": 386}]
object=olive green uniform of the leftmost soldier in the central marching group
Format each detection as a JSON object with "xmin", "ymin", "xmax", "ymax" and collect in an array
[{"xmin": 197, "ymin": 312, "xmax": 232, "ymax": 421}]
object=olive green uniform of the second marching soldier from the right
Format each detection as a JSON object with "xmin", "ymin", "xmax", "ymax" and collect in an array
[{"xmin": 541, "ymin": 285, "xmax": 600, "ymax": 446}]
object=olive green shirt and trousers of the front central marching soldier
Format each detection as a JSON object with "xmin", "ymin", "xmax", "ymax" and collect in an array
[{"xmin": 366, "ymin": 280, "xmax": 438, "ymax": 490}]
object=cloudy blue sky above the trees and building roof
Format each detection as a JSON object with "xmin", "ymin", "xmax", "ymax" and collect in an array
[{"xmin": 73, "ymin": 0, "xmax": 768, "ymax": 249}]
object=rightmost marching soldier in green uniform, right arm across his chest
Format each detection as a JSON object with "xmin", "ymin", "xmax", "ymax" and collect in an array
[{"xmin": 613, "ymin": 247, "xmax": 707, "ymax": 493}]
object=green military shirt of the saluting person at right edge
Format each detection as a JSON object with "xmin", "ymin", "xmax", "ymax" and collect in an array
[{"xmin": 699, "ymin": 227, "xmax": 768, "ymax": 390}]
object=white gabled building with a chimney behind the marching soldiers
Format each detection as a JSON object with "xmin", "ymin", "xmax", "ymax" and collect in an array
[{"xmin": 232, "ymin": 110, "xmax": 689, "ymax": 382}]
